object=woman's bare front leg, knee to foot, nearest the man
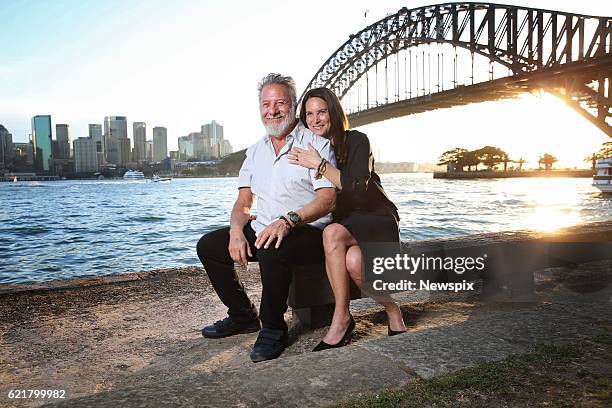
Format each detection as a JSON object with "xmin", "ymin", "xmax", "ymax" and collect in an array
[{"xmin": 323, "ymin": 224, "xmax": 357, "ymax": 344}]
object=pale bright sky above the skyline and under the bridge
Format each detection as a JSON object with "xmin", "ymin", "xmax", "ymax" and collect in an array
[{"xmin": 0, "ymin": 0, "xmax": 612, "ymax": 167}]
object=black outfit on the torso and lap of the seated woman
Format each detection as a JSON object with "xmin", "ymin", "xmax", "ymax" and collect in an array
[{"xmin": 333, "ymin": 130, "xmax": 399, "ymax": 243}]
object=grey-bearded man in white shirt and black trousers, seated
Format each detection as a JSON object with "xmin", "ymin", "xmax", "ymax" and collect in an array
[{"xmin": 197, "ymin": 74, "xmax": 336, "ymax": 362}]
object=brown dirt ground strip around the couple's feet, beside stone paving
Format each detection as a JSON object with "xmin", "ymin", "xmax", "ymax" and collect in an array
[{"xmin": 0, "ymin": 266, "xmax": 608, "ymax": 406}]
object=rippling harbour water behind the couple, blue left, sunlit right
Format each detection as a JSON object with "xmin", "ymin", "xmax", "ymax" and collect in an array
[{"xmin": 0, "ymin": 173, "xmax": 612, "ymax": 284}]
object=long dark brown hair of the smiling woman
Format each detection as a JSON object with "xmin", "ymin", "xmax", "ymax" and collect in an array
[{"xmin": 300, "ymin": 88, "xmax": 349, "ymax": 169}]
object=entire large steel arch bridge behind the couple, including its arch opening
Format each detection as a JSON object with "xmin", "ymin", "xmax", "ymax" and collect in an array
[{"xmin": 306, "ymin": 2, "xmax": 612, "ymax": 137}]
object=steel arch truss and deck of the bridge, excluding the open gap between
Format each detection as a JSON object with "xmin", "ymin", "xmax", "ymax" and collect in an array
[{"xmin": 306, "ymin": 2, "xmax": 612, "ymax": 137}]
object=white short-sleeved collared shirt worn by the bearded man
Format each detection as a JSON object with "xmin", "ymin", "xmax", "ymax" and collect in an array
[{"xmin": 238, "ymin": 122, "xmax": 336, "ymax": 235}]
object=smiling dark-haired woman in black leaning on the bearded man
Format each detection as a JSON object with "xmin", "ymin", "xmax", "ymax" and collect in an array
[{"xmin": 288, "ymin": 88, "xmax": 406, "ymax": 351}]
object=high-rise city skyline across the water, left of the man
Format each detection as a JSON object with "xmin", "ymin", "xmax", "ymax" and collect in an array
[{"xmin": 0, "ymin": 115, "xmax": 233, "ymax": 177}]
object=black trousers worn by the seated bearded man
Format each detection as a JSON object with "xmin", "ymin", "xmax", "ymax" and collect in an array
[{"xmin": 197, "ymin": 221, "xmax": 325, "ymax": 331}]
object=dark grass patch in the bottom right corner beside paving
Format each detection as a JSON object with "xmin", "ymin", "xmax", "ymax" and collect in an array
[{"xmin": 337, "ymin": 333, "xmax": 612, "ymax": 408}]
